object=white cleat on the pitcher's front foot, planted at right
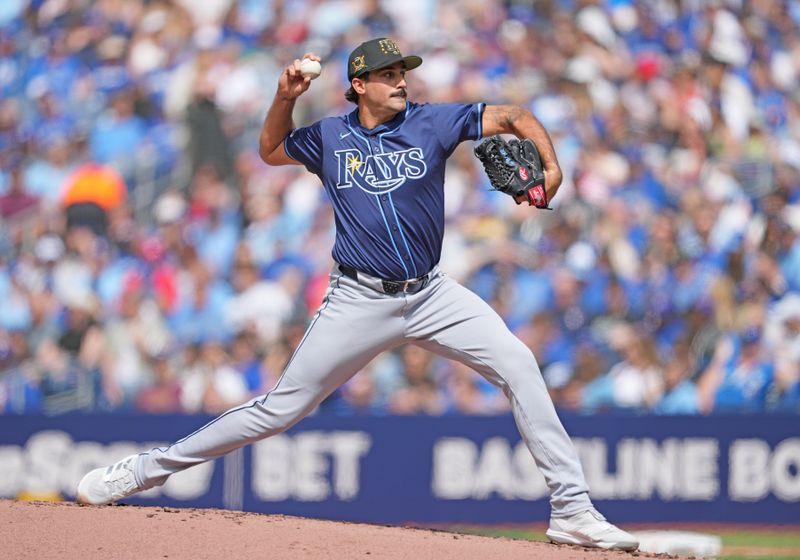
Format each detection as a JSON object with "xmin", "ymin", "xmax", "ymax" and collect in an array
[{"xmin": 545, "ymin": 508, "xmax": 639, "ymax": 550}]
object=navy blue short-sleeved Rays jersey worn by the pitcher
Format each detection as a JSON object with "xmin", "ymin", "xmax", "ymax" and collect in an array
[{"xmin": 284, "ymin": 102, "xmax": 485, "ymax": 280}]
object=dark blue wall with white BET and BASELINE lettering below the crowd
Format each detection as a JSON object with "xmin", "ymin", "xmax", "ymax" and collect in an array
[{"xmin": 0, "ymin": 414, "xmax": 800, "ymax": 524}]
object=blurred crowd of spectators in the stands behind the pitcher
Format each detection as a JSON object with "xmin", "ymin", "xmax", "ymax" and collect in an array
[{"xmin": 0, "ymin": 0, "xmax": 800, "ymax": 415}]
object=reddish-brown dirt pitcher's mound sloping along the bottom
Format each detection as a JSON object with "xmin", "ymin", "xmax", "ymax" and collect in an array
[{"xmin": 0, "ymin": 500, "xmax": 675, "ymax": 560}]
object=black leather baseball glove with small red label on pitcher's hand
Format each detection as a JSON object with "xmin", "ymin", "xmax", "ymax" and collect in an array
[{"xmin": 475, "ymin": 135, "xmax": 550, "ymax": 209}]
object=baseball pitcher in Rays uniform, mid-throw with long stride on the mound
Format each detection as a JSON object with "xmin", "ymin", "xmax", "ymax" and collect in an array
[{"xmin": 77, "ymin": 38, "xmax": 638, "ymax": 550}]
